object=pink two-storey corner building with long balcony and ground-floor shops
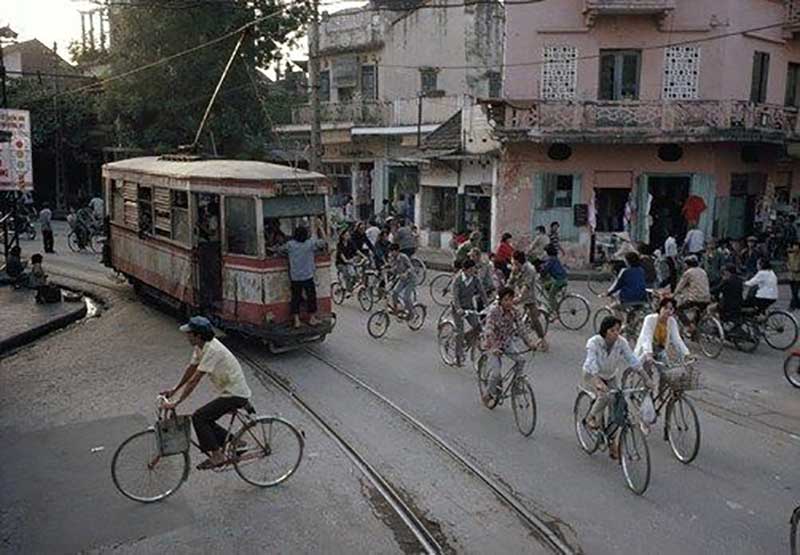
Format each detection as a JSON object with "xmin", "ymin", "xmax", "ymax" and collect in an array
[{"xmin": 489, "ymin": 0, "xmax": 800, "ymax": 262}]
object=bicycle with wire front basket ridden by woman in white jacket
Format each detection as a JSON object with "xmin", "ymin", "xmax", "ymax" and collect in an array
[{"xmin": 628, "ymin": 360, "xmax": 700, "ymax": 464}]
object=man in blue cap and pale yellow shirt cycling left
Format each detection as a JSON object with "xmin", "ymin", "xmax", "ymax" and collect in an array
[{"xmin": 161, "ymin": 316, "xmax": 252, "ymax": 470}]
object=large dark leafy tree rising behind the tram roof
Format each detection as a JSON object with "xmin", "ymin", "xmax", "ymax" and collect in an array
[{"xmin": 100, "ymin": 0, "xmax": 311, "ymax": 158}]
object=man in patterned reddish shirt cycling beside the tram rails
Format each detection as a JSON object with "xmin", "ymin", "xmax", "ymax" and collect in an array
[{"xmin": 481, "ymin": 288, "xmax": 534, "ymax": 406}]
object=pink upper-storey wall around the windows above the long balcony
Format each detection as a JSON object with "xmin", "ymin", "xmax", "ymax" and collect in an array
[{"xmin": 504, "ymin": 0, "xmax": 800, "ymax": 104}]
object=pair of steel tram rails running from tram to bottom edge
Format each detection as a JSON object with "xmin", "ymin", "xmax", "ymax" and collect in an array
[{"xmin": 235, "ymin": 348, "xmax": 580, "ymax": 554}]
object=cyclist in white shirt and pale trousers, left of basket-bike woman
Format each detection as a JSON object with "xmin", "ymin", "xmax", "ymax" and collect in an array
[{"xmin": 582, "ymin": 316, "xmax": 642, "ymax": 459}]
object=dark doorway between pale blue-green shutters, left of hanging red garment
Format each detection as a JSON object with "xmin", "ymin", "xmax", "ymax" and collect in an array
[{"xmin": 647, "ymin": 175, "xmax": 691, "ymax": 249}]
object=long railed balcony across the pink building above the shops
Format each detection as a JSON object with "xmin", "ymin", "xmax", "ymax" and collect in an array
[{"xmin": 490, "ymin": 100, "xmax": 800, "ymax": 144}]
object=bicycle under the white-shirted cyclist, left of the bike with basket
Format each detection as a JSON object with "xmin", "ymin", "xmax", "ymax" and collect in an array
[{"xmin": 572, "ymin": 374, "xmax": 650, "ymax": 495}]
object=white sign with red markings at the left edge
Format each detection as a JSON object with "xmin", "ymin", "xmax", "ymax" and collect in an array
[{"xmin": 0, "ymin": 109, "xmax": 33, "ymax": 191}]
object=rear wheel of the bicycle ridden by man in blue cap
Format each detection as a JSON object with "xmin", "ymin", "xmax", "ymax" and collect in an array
[{"xmin": 232, "ymin": 416, "xmax": 305, "ymax": 488}]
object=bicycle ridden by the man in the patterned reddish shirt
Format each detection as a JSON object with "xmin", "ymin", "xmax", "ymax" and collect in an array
[{"xmin": 476, "ymin": 349, "xmax": 536, "ymax": 437}]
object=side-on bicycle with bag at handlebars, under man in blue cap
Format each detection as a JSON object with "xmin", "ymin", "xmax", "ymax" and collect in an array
[{"xmin": 111, "ymin": 395, "xmax": 305, "ymax": 503}]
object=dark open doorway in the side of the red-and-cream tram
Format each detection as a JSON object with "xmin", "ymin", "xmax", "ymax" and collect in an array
[{"xmin": 194, "ymin": 193, "xmax": 222, "ymax": 308}]
